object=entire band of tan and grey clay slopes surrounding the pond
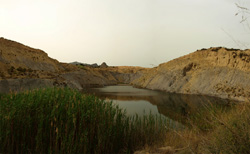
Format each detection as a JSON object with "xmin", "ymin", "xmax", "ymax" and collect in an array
[{"xmin": 0, "ymin": 38, "xmax": 250, "ymax": 101}]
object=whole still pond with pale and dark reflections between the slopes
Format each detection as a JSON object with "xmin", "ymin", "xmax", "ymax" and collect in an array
[{"xmin": 85, "ymin": 85, "xmax": 232, "ymax": 125}]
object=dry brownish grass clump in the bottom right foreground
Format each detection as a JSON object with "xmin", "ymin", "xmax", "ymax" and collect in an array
[{"xmin": 173, "ymin": 103, "xmax": 250, "ymax": 154}]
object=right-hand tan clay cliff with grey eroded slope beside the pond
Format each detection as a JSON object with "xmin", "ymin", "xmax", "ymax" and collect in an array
[{"xmin": 132, "ymin": 47, "xmax": 250, "ymax": 101}]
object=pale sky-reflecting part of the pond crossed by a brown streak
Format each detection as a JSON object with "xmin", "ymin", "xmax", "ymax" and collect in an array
[{"xmin": 85, "ymin": 85, "xmax": 159, "ymax": 115}]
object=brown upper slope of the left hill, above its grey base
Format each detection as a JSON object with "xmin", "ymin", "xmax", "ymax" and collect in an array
[{"xmin": 0, "ymin": 38, "xmax": 79, "ymax": 79}]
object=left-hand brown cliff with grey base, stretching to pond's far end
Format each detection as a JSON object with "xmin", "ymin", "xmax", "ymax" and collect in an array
[{"xmin": 0, "ymin": 38, "xmax": 144, "ymax": 93}]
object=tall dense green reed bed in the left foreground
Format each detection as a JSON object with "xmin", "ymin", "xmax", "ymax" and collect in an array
[{"xmin": 0, "ymin": 88, "xmax": 168, "ymax": 153}]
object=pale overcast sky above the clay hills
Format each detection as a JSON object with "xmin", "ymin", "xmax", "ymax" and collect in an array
[{"xmin": 0, "ymin": 0, "xmax": 250, "ymax": 67}]
